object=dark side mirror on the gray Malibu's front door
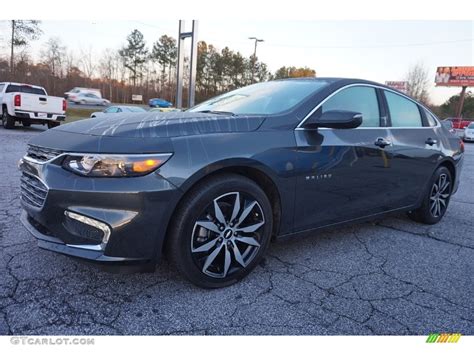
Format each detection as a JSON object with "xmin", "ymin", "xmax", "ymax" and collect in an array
[{"xmin": 305, "ymin": 110, "xmax": 362, "ymax": 129}]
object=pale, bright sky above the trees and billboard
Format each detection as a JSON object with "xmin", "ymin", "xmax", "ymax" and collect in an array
[{"xmin": 0, "ymin": 19, "xmax": 474, "ymax": 104}]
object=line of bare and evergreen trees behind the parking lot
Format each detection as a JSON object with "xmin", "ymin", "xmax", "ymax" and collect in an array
[{"xmin": 0, "ymin": 20, "xmax": 316, "ymax": 103}]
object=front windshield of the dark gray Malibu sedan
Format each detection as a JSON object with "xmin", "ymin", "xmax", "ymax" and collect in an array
[{"xmin": 189, "ymin": 80, "xmax": 329, "ymax": 114}]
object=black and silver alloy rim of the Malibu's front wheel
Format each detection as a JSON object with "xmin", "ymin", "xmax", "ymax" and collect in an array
[{"xmin": 191, "ymin": 192, "xmax": 265, "ymax": 278}]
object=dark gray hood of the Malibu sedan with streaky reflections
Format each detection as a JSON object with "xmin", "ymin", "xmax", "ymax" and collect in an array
[{"xmin": 55, "ymin": 112, "xmax": 265, "ymax": 138}]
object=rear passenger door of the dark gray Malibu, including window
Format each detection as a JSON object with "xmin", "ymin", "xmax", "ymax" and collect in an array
[{"xmin": 383, "ymin": 90, "xmax": 441, "ymax": 207}]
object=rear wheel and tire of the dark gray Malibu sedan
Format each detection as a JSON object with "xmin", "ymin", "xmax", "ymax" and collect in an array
[{"xmin": 408, "ymin": 166, "xmax": 454, "ymax": 224}]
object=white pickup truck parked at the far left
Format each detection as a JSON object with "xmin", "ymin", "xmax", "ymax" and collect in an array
[{"xmin": 0, "ymin": 83, "xmax": 66, "ymax": 129}]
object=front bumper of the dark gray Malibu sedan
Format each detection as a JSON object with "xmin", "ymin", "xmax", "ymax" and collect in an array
[{"xmin": 19, "ymin": 160, "xmax": 181, "ymax": 264}]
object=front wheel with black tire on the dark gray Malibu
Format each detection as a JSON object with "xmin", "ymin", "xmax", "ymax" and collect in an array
[{"xmin": 167, "ymin": 174, "xmax": 273, "ymax": 288}]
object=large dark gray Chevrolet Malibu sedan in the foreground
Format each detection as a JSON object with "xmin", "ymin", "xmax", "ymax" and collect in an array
[{"xmin": 19, "ymin": 78, "xmax": 464, "ymax": 288}]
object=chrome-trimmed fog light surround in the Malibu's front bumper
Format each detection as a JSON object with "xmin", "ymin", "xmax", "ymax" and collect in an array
[{"xmin": 64, "ymin": 211, "xmax": 110, "ymax": 250}]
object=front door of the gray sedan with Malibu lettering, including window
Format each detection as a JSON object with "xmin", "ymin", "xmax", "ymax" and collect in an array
[{"xmin": 295, "ymin": 85, "xmax": 393, "ymax": 231}]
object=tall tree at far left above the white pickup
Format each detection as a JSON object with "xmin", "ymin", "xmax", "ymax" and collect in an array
[{"xmin": 10, "ymin": 20, "xmax": 43, "ymax": 79}]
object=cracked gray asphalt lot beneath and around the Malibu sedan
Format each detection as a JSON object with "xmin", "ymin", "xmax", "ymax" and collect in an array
[{"xmin": 0, "ymin": 127, "xmax": 474, "ymax": 335}]
